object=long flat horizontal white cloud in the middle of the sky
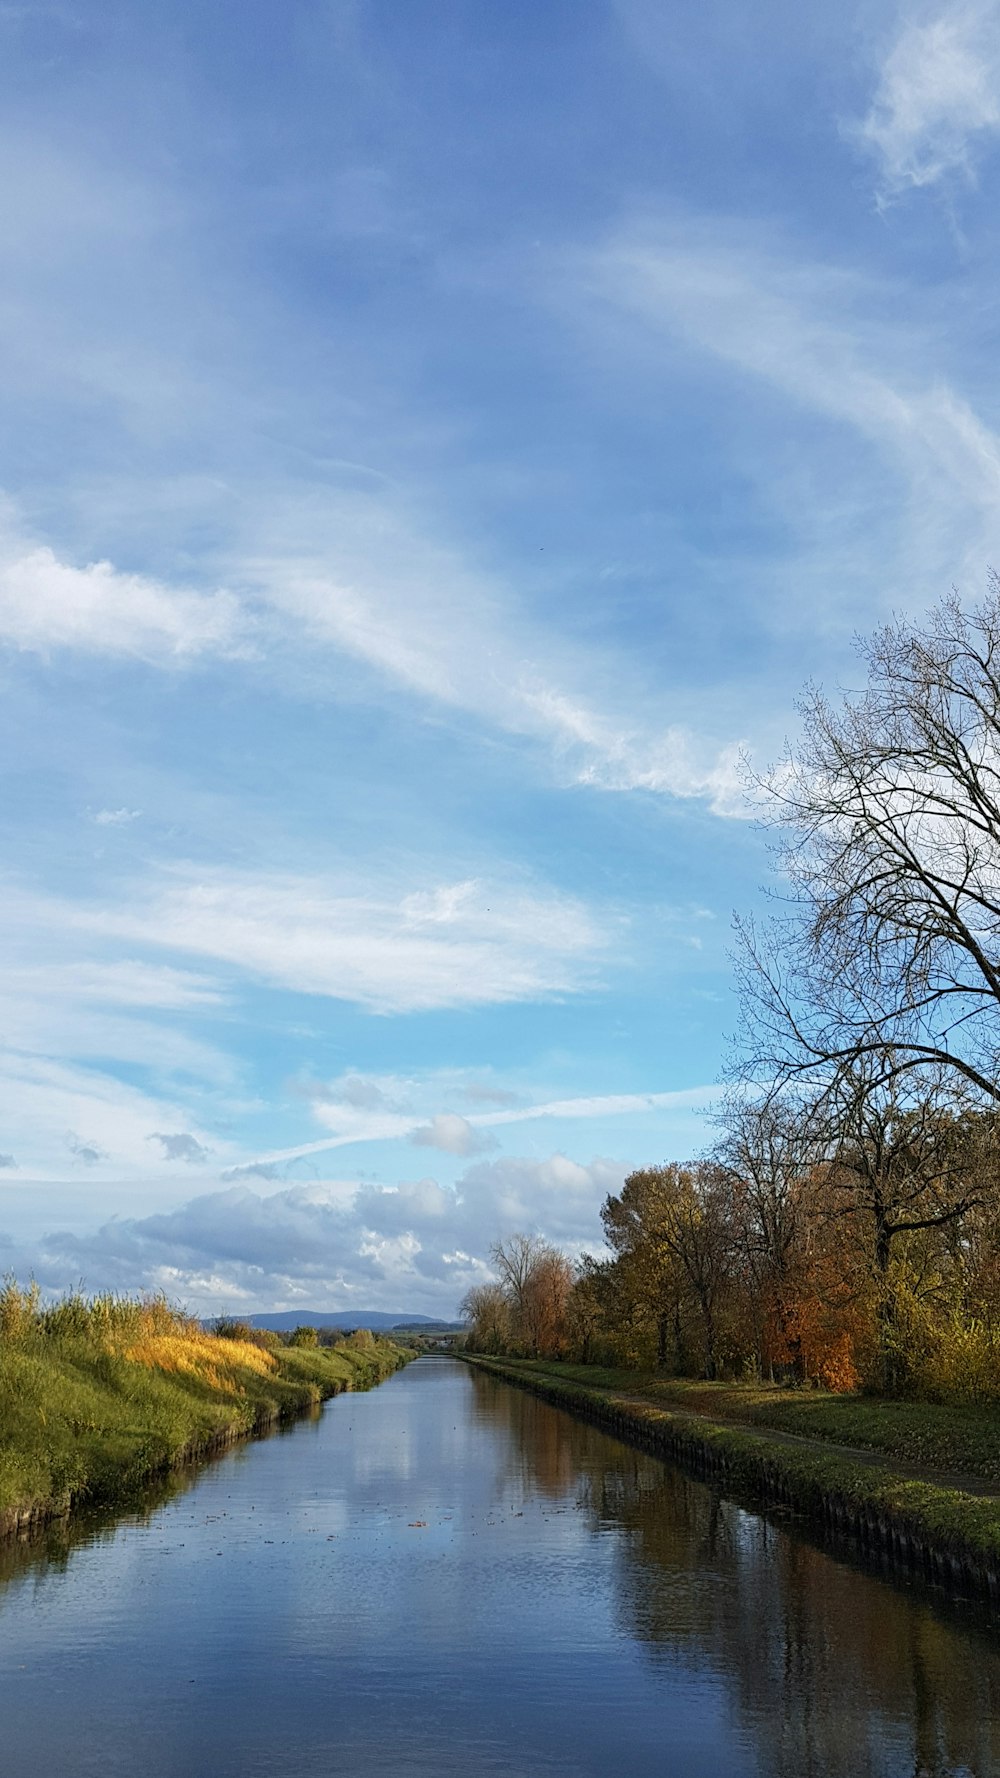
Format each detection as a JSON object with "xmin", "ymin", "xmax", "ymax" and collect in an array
[{"xmin": 76, "ymin": 868, "xmax": 610, "ymax": 1012}]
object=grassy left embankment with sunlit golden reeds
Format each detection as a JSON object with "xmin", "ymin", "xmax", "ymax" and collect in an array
[{"xmin": 0, "ymin": 1285, "xmax": 413, "ymax": 1536}]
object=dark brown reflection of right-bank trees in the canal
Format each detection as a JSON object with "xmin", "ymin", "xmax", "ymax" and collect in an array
[{"xmin": 475, "ymin": 1373, "xmax": 1000, "ymax": 1778}]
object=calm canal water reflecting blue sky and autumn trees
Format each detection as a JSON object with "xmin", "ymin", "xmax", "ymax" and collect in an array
[{"xmin": 0, "ymin": 1358, "xmax": 1000, "ymax": 1778}]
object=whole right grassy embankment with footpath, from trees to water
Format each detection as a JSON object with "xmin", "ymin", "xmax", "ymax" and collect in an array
[{"xmin": 473, "ymin": 1358, "xmax": 1000, "ymax": 1602}]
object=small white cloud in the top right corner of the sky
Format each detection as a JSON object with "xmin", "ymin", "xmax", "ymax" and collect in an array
[{"xmin": 854, "ymin": 0, "xmax": 1000, "ymax": 196}]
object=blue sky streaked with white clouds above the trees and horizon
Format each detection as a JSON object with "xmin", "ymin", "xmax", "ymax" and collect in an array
[{"xmin": 0, "ymin": 0, "xmax": 1000, "ymax": 1316}]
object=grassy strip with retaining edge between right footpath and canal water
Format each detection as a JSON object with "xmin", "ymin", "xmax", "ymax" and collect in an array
[{"xmin": 464, "ymin": 1355, "xmax": 1000, "ymax": 1609}]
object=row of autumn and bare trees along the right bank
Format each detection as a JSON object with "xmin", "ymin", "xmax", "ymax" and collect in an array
[{"xmin": 463, "ymin": 578, "xmax": 1000, "ymax": 1399}]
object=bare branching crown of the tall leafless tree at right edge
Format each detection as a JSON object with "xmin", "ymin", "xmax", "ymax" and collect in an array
[{"xmin": 738, "ymin": 576, "xmax": 1000, "ymax": 1101}]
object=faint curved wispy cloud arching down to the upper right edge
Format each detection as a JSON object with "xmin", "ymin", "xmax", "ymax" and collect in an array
[{"xmin": 577, "ymin": 220, "xmax": 1000, "ymax": 604}]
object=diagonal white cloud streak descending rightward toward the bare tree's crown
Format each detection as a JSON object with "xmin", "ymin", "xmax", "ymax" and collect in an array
[{"xmin": 233, "ymin": 493, "xmax": 744, "ymax": 814}]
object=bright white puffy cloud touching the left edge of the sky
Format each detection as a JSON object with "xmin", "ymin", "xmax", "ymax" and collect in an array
[{"xmin": 0, "ymin": 539, "xmax": 249, "ymax": 668}]
